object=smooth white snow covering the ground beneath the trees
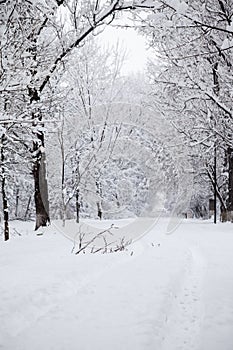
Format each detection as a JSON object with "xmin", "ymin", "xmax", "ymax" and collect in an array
[{"xmin": 0, "ymin": 218, "xmax": 233, "ymax": 350}]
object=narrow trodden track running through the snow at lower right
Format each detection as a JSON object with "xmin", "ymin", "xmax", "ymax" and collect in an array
[{"xmin": 160, "ymin": 247, "xmax": 205, "ymax": 350}]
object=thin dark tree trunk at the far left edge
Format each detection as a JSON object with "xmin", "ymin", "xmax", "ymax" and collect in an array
[{"xmin": 1, "ymin": 135, "xmax": 10, "ymax": 241}]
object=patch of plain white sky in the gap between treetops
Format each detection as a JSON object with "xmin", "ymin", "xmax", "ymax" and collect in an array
[{"xmin": 99, "ymin": 26, "xmax": 148, "ymax": 74}]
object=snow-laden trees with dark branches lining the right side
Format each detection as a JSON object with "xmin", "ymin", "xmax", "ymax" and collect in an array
[{"xmin": 145, "ymin": 0, "xmax": 233, "ymax": 220}]
